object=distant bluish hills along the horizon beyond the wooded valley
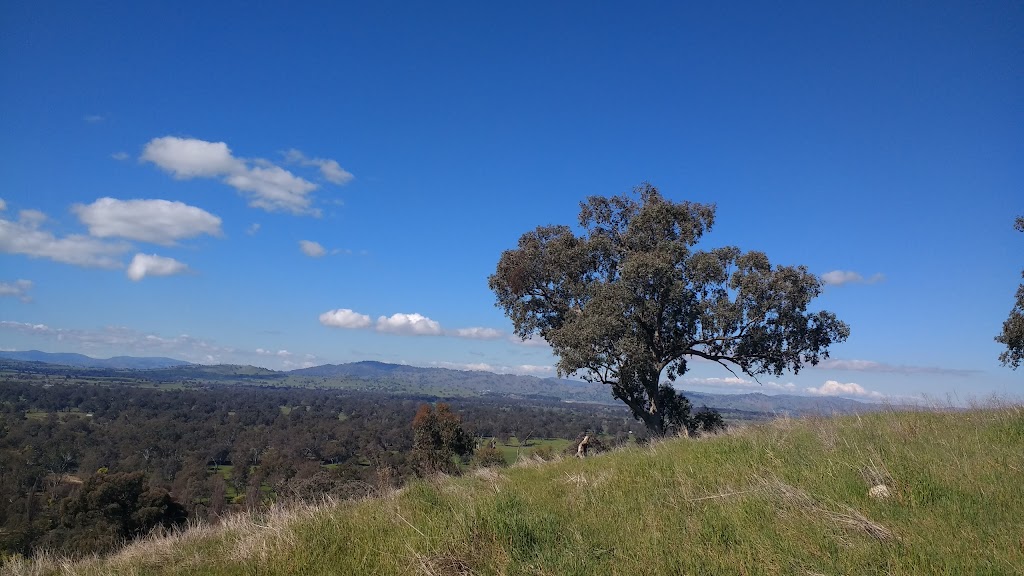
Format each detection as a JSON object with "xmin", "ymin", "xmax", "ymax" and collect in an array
[{"xmin": 0, "ymin": 351, "xmax": 888, "ymax": 416}]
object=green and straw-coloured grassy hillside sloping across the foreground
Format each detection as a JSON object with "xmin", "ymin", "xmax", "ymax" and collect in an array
[{"xmin": 5, "ymin": 406, "xmax": 1024, "ymax": 575}]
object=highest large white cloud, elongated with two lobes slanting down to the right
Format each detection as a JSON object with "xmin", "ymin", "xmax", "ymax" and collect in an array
[{"xmin": 140, "ymin": 136, "xmax": 323, "ymax": 215}]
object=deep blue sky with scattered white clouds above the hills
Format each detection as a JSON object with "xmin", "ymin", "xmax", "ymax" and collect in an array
[{"xmin": 0, "ymin": 1, "xmax": 1024, "ymax": 402}]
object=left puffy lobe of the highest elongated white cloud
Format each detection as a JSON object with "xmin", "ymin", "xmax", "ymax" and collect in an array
[{"xmin": 140, "ymin": 136, "xmax": 246, "ymax": 179}]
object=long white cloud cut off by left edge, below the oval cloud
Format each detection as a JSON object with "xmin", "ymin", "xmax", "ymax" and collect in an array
[{"xmin": 0, "ymin": 210, "xmax": 130, "ymax": 269}]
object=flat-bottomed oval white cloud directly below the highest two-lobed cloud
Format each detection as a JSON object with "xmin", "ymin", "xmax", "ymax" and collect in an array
[{"xmin": 72, "ymin": 198, "xmax": 221, "ymax": 246}]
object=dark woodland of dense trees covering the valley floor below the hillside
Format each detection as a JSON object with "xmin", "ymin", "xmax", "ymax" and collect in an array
[{"xmin": 0, "ymin": 379, "xmax": 645, "ymax": 556}]
